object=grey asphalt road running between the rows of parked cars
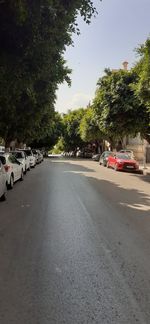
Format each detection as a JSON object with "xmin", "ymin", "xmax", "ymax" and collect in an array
[{"xmin": 0, "ymin": 159, "xmax": 150, "ymax": 324}]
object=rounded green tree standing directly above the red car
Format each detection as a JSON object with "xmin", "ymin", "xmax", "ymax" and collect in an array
[{"xmin": 93, "ymin": 69, "xmax": 144, "ymax": 144}]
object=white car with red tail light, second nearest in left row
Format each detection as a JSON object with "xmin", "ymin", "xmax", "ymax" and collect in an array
[{"xmin": 0, "ymin": 153, "xmax": 23, "ymax": 189}]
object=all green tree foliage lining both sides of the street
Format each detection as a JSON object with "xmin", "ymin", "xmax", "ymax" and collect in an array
[{"xmin": 0, "ymin": 0, "xmax": 150, "ymax": 151}]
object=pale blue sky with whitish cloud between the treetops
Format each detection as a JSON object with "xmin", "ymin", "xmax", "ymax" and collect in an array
[{"xmin": 55, "ymin": 0, "xmax": 150, "ymax": 113}]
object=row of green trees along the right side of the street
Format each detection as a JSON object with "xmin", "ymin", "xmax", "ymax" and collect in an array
[{"xmin": 51, "ymin": 39, "xmax": 150, "ymax": 151}]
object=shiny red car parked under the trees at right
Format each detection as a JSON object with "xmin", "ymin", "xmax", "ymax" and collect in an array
[{"xmin": 107, "ymin": 153, "xmax": 139, "ymax": 171}]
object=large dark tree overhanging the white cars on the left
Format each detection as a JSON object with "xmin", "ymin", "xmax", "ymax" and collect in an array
[{"xmin": 0, "ymin": 0, "xmax": 96, "ymax": 145}]
